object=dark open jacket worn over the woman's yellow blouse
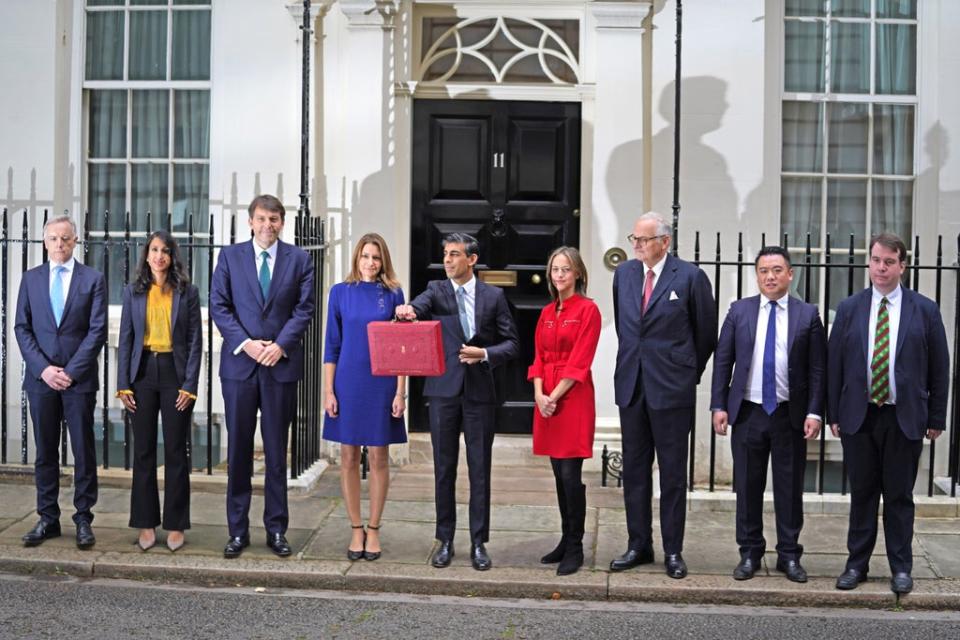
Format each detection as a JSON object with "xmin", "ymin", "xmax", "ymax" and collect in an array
[{"xmin": 117, "ymin": 284, "xmax": 203, "ymax": 395}]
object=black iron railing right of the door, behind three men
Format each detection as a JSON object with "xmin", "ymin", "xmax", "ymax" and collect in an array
[{"xmin": 601, "ymin": 232, "xmax": 960, "ymax": 497}]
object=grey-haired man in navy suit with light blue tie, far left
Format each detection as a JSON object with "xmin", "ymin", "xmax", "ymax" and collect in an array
[{"xmin": 14, "ymin": 215, "xmax": 107, "ymax": 549}]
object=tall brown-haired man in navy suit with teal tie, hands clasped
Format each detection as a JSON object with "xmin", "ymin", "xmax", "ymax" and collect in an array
[{"xmin": 210, "ymin": 195, "xmax": 314, "ymax": 558}]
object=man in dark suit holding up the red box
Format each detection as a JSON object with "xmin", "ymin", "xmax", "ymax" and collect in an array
[{"xmin": 396, "ymin": 233, "xmax": 520, "ymax": 571}]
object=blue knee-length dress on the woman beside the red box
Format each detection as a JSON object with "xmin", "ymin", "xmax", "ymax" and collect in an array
[{"xmin": 323, "ymin": 282, "xmax": 407, "ymax": 447}]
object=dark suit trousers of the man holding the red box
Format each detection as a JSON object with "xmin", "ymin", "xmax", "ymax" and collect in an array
[{"xmin": 430, "ymin": 396, "xmax": 496, "ymax": 544}]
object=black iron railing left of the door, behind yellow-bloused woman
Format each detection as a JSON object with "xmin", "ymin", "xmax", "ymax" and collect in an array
[{"xmin": 0, "ymin": 208, "xmax": 326, "ymax": 478}]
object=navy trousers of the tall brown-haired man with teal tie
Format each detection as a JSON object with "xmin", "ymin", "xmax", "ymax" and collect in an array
[{"xmin": 221, "ymin": 366, "xmax": 297, "ymax": 536}]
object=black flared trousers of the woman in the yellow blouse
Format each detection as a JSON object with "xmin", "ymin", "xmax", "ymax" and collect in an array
[{"xmin": 130, "ymin": 351, "xmax": 193, "ymax": 531}]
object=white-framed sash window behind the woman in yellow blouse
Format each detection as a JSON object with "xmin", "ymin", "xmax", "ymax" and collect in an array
[{"xmin": 83, "ymin": 0, "xmax": 211, "ymax": 303}]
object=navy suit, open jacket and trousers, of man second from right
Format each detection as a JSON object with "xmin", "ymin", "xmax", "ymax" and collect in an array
[{"xmin": 710, "ymin": 295, "xmax": 827, "ymax": 561}]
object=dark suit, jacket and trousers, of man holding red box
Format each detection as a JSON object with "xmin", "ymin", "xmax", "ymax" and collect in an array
[{"xmin": 410, "ymin": 279, "xmax": 520, "ymax": 544}]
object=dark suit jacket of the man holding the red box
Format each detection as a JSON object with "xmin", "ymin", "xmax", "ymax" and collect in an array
[{"xmin": 410, "ymin": 279, "xmax": 520, "ymax": 404}]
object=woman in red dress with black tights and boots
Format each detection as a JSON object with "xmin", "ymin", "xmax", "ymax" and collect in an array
[{"xmin": 527, "ymin": 247, "xmax": 600, "ymax": 576}]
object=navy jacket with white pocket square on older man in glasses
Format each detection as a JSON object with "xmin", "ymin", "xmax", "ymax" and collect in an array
[{"xmin": 613, "ymin": 254, "xmax": 717, "ymax": 410}]
